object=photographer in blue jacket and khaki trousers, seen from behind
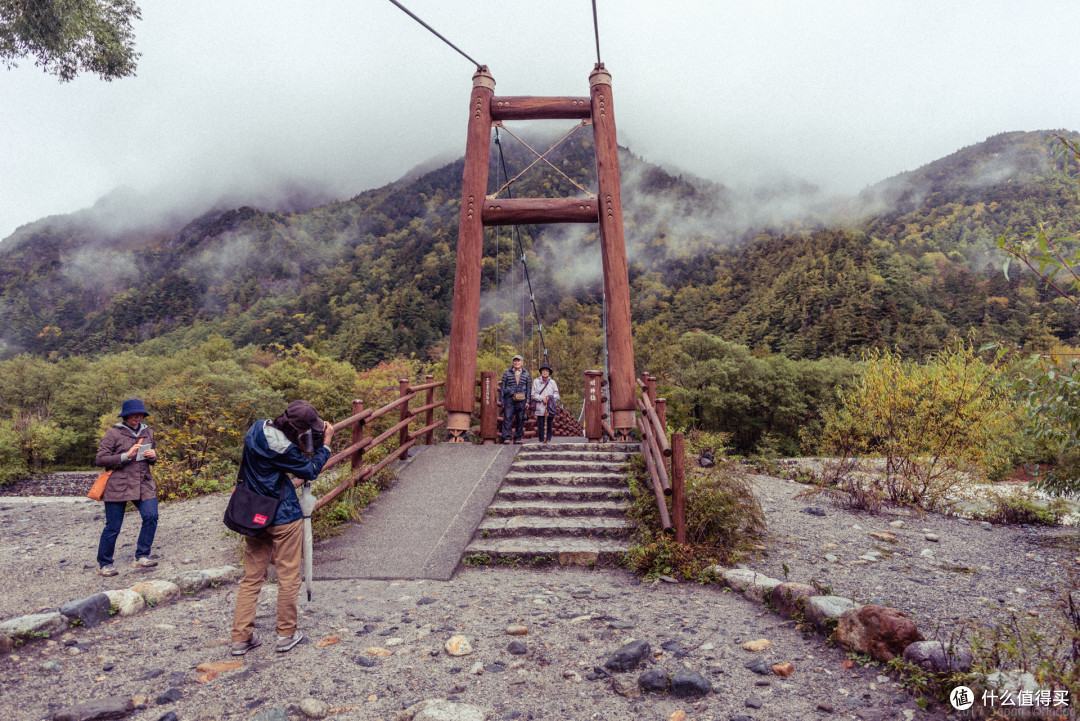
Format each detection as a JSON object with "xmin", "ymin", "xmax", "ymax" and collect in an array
[{"xmin": 226, "ymin": 400, "xmax": 334, "ymax": 656}]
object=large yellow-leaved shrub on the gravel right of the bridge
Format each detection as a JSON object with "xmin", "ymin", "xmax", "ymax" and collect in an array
[{"xmin": 821, "ymin": 345, "xmax": 1018, "ymax": 511}]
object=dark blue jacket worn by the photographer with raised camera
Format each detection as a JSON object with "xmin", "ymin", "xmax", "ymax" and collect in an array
[{"xmin": 238, "ymin": 420, "xmax": 330, "ymax": 526}]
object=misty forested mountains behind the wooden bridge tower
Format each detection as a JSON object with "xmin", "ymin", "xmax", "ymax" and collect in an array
[{"xmin": 0, "ymin": 127, "xmax": 1080, "ymax": 368}]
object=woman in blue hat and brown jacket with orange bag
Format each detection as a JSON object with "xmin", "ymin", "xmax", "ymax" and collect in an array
[{"xmin": 94, "ymin": 398, "xmax": 158, "ymax": 576}]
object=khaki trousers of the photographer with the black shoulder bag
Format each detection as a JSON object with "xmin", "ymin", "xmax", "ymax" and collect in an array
[{"xmin": 232, "ymin": 520, "xmax": 303, "ymax": 641}]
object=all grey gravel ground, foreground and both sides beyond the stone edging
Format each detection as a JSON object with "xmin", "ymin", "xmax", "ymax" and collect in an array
[{"xmin": 0, "ymin": 461, "xmax": 1076, "ymax": 721}]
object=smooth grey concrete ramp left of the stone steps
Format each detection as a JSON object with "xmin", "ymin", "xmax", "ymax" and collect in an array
[{"xmin": 314, "ymin": 444, "xmax": 521, "ymax": 581}]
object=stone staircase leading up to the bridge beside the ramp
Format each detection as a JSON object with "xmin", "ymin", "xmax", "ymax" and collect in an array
[{"xmin": 464, "ymin": 443, "xmax": 637, "ymax": 566}]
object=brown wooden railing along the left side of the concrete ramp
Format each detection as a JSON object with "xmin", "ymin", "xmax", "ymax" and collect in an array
[{"xmin": 293, "ymin": 376, "xmax": 446, "ymax": 511}]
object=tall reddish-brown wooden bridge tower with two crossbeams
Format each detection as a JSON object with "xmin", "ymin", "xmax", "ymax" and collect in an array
[{"xmin": 446, "ymin": 63, "xmax": 635, "ymax": 439}]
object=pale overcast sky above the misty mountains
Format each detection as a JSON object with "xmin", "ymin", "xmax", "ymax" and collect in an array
[{"xmin": 0, "ymin": 0, "xmax": 1080, "ymax": 239}]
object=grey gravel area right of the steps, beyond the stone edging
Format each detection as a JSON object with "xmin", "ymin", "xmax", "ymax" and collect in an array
[{"xmin": 747, "ymin": 475, "xmax": 1080, "ymax": 639}]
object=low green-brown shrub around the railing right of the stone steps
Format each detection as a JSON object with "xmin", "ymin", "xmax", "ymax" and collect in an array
[{"xmin": 629, "ymin": 432, "xmax": 766, "ymax": 580}]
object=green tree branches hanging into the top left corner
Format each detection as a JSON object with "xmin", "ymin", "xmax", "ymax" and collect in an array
[{"xmin": 0, "ymin": 0, "xmax": 141, "ymax": 82}]
